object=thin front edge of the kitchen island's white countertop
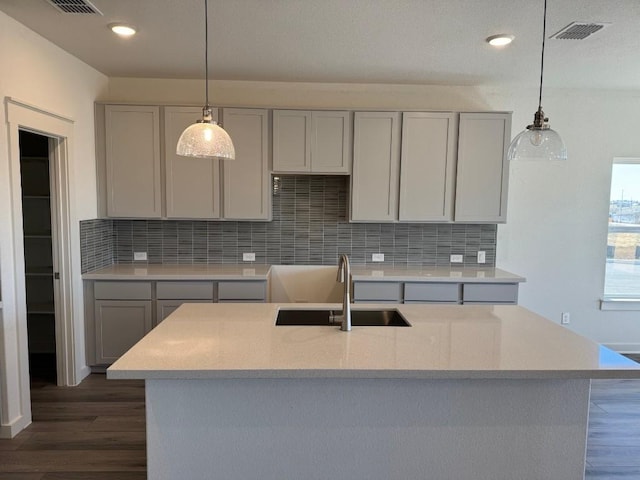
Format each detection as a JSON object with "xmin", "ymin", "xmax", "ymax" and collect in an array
[{"xmin": 107, "ymin": 368, "xmax": 638, "ymax": 380}]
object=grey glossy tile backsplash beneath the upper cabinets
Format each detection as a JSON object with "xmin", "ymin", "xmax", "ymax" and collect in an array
[{"xmin": 80, "ymin": 175, "xmax": 497, "ymax": 272}]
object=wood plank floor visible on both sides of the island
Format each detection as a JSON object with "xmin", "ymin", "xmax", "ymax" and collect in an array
[{"xmin": 0, "ymin": 374, "xmax": 640, "ymax": 480}]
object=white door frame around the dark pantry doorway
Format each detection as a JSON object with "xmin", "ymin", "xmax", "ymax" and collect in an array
[{"xmin": 0, "ymin": 97, "xmax": 80, "ymax": 438}]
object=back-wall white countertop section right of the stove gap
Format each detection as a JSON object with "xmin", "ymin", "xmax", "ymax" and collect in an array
[{"xmin": 351, "ymin": 266, "xmax": 525, "ymax": 283}]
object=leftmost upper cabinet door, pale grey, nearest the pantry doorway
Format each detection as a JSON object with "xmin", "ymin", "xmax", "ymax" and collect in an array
[{"xmin": 105, "ymin": 105, "xmax": 162, "ymax": 218}]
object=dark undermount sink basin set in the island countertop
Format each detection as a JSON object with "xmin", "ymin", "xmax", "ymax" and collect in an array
[{"xmin": 276, "ymin": 309, "xmax": 411, "ymax": 327}]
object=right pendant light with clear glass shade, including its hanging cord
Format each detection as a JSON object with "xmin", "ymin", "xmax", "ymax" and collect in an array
[{"xmin": 508, "ymin": 0, "xmax": 567, "ymax": 160}]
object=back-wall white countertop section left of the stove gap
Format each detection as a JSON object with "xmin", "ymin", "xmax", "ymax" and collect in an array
[{"xmin": 82, "ymin": 264, "xmax": 271, "ymax": 280}]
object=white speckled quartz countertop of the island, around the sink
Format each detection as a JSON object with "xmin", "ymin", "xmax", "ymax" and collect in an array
[{"xmin": 107, "ymin": 304, "xmax": 640, "ymax": 379}]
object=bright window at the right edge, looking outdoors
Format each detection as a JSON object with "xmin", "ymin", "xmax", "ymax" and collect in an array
[{"xmin": 604, "ymin": 158, "xmax": 640, "ymax": 307}]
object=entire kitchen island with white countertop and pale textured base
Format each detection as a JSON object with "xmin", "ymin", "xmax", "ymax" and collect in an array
[{"xmin": 107, "ymin": 304, "xmax": 640, "ymax": 480}]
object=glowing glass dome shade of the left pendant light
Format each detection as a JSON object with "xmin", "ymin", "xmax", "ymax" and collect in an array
[{"xmin": 176, "ymin": 105, "xmax": 236, "ymax": 160}]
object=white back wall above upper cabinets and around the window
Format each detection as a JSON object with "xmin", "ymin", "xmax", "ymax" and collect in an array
[{"xmin": 107, "ymin": 78, "xmax": 640, "ymax": 351}]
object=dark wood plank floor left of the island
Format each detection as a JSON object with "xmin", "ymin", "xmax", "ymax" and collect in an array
[{"xmin": 0, "ymin": 375, "xmax": 147, "ymax": 480}]
